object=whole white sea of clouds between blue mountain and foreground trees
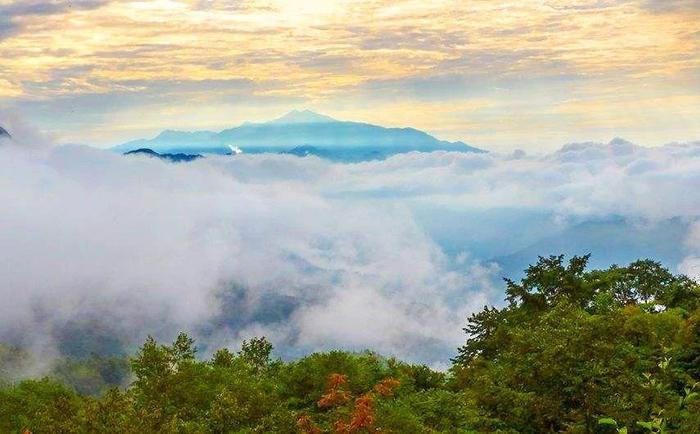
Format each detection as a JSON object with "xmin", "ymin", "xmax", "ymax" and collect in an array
[{"xmin": 0, "ymin": 131, "xmax": 700, "ymax": 366}]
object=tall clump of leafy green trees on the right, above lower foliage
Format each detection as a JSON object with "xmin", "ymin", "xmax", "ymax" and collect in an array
[{"xmin": 453, "ymin": 256, "xmax": 700, "ymax": 433}]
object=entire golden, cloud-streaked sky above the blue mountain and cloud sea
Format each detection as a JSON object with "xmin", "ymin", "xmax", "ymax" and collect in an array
[{"xmin": 0, "ymin": 0, "xmax": 700, "ymax": 151}]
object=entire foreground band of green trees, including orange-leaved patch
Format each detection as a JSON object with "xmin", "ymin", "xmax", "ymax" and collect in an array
[{"xmin": 0, "ymin": 256, "xmax": 700, "ymax": 434}]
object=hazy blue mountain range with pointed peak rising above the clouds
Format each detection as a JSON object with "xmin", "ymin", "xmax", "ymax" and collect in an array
[{"xmin": 113, "ymin": 110, "xmax": 485, "ymax": 161}]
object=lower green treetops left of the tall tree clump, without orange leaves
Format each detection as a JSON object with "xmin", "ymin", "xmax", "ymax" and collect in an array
[{"xmin": 0, "ymin": 334, "xmax": 478, "ymax": 433}]
